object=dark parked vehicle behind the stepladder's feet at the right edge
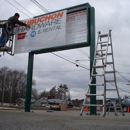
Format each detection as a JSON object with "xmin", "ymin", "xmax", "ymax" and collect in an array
[{"xmin": 106, "ymin": 98, "xmax": 130, "ymax": 112}]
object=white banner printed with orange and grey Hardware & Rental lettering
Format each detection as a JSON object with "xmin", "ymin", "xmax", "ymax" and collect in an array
[{"xmin": 14, "ymin": 10, "xmax": 66, "ymax": 54}]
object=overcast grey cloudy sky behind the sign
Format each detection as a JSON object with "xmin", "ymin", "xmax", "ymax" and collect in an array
[{"xmin": 0, "ymin": 0, "xmax": 130, "ymax": 99}]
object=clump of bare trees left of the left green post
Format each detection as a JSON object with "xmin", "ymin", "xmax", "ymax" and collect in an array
[{"xmin": 0, "ymin": 67, "xmax": 36, "ymax": 103}]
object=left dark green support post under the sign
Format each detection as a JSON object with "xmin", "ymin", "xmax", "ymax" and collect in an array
[{"xmin": 25, "ymin": 52, "xmax": 34, "ymax": 112}]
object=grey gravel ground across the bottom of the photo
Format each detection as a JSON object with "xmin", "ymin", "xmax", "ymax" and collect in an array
[{"xmin": 0, "ymin": 110, "xmax": 130, "ymax": 130}]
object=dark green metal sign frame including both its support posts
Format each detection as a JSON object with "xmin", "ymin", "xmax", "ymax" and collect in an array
[{"xmin": 25, "ymin": 3, "xmax": 97, "ymax": 115}]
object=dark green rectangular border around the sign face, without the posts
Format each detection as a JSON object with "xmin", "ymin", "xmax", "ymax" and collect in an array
[{"xmin": 31, "ymin": 3, "xmax": 91, "ymax": 54}]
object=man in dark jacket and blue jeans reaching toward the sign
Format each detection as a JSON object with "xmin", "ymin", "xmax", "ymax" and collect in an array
[{"xmin": 0, "ymin": 13, "xmax": 30, "ymax": 47}]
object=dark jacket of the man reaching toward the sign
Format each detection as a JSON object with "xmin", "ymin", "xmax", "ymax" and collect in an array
[{"xmin": 8, "ymin": 16, "xmax": 27, "ymax": 27}]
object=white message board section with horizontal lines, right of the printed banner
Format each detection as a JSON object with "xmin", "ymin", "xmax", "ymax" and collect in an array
[{"xmin": 66, "ymin": 10, "xmax": 87, "ymax": 44}]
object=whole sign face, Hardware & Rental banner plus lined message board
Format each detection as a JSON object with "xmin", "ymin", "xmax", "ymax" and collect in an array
[{"xmin": 14, "ymin": 5, "xmax": 88, "ymax": 54}]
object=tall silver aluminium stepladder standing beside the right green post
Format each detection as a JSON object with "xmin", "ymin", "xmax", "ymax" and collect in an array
[{"xmin": 80, "ymin": 30, "xmax": 124, "ymax": 117}]
